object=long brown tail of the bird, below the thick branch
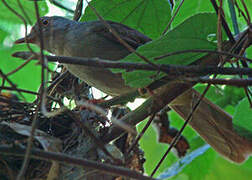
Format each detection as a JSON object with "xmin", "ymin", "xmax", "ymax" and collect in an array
[{"xmin": 170, "ymin": 89, "xmax": 252, "ymax": 163}]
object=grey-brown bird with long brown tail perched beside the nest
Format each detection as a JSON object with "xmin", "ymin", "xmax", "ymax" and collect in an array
[{"xmin": 15, "ymin": 16, "xmax": 252, "ymax": 163}]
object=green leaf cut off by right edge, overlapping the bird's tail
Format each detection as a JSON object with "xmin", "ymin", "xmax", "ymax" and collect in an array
[{"xmin": 233, "ymin": 98, "xmax": 252, "ymax": 139}]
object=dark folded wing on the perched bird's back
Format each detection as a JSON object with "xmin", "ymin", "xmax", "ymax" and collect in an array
[{"xmin": 92, "ymin": 21, "xmax": 151, "ymax": 49}]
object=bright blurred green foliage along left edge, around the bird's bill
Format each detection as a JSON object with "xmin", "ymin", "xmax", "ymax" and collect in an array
[{"xmin": 0, "ymin": 0, "xmax": 48, "ymax": 101}]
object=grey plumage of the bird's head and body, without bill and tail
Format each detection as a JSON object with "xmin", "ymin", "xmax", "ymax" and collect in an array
[{"xmin": 24, "ymin": 16, "xmax": 151, "ymax": 95}]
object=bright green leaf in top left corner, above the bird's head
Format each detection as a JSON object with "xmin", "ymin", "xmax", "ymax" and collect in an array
[{"xmin": 0, "ymin": 0, "xmax": 48, "ymax": 24}]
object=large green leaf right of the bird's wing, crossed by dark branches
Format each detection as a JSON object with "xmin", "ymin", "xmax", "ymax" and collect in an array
[{"xmin": 113, "ymin": 13, "xmax": 217, "ymax": 87}]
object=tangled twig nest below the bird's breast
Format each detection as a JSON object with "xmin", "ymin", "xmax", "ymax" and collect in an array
[{"xmin": 0, "ymin": 73, "xmax": 144, "ymax": 180}]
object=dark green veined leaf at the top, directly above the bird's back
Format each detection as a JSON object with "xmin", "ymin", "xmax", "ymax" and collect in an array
[{"xmin": 81, "ymin": 0, "xmax": 171, "ymax": 38}]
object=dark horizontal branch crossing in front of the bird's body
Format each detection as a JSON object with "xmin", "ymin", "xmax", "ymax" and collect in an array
[{"xmin": 13, "ymin": 52, "xmax": 252, "ymax": 76}]
